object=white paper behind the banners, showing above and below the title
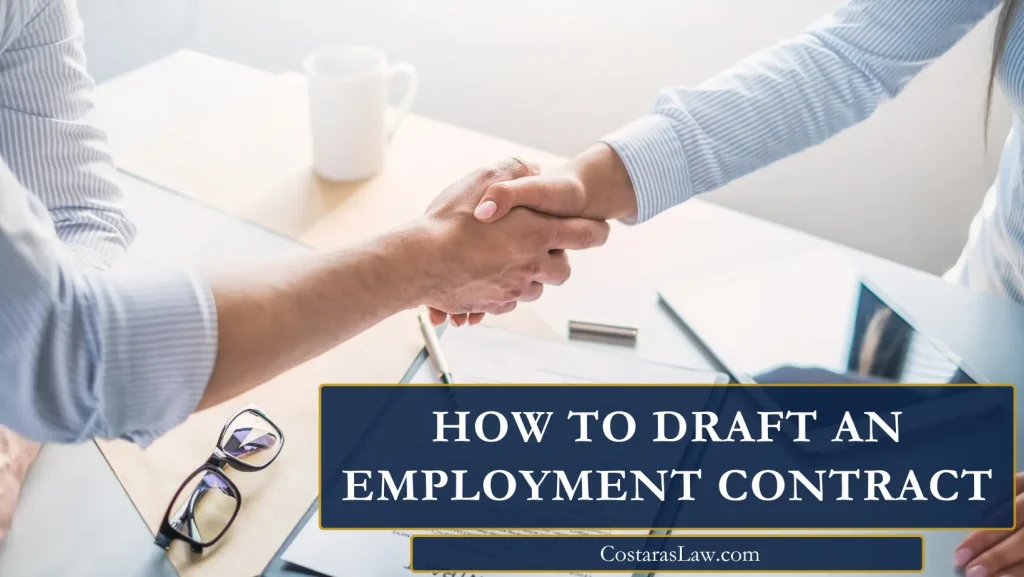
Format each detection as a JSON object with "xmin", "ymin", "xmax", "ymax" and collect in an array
[{"xmin": 283, "ymin": 326, "xmax": 725, "ymax": 577}]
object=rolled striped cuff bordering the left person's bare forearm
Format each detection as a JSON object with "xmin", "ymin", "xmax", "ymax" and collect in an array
[{"xmin": 83, "ymin": 271, "xmax": 217, "ymax": 448}]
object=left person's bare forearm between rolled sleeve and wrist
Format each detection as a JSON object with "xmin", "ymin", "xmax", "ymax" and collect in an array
[{"xmin": 199, "ymin": 223, "xmax": 430, "ymax": 409}]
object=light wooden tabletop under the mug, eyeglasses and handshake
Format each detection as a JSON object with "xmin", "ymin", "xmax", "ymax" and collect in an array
[{"xmin": 97, "ymin": 51, "xmax": 909, "ymax": 576}]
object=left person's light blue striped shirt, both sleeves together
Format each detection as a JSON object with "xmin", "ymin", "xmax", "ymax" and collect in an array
[{"xmin": 0, "ymin": 0, "xmax": 217, "ymax": 446}]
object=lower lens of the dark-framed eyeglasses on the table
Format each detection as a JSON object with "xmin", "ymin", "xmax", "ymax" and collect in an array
[{"xmin": 168, "ymin": 469, "xmax": 240, "ymax": 545}]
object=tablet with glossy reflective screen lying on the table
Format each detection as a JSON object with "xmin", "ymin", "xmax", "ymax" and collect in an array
[{"xmin": 659, "ymin": 252, "xmax": 992, "ymax": 448}]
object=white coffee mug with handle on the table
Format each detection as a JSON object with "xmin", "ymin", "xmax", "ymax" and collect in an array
[{"xmin": 303, "ymin": 46, "xmax": 419, "ymax": 181}]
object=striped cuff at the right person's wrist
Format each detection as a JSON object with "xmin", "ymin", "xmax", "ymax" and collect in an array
[{"xmin": 601, "ymin": 115, "xmax": 693, "ymax": 224}]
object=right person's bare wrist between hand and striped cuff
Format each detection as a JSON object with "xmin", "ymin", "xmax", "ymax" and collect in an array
[{"xmin": 565, "ymin": 142, "xmax": 637, "ymax": 220}]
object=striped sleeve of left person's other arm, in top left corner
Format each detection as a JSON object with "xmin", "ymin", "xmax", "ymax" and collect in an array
[{"xmin": 0, "ymin": 0, "xmax": 135, "ymax": 269}]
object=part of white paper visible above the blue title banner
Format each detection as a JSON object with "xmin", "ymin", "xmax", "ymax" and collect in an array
[{"xmin": 412, "ymin": 326, "xmax": 724, "ymax": 384}]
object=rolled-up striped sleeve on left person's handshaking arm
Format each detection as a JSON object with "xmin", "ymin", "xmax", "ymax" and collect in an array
[{"xmin": 0, "ymin": 162, "xmax": 217, "ymax": 446}]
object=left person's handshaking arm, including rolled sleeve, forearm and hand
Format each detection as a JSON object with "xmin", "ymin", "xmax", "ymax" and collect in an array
[{"xmin": 6, "ymin": 155, "xmax": 593, "ymax": 445}]
